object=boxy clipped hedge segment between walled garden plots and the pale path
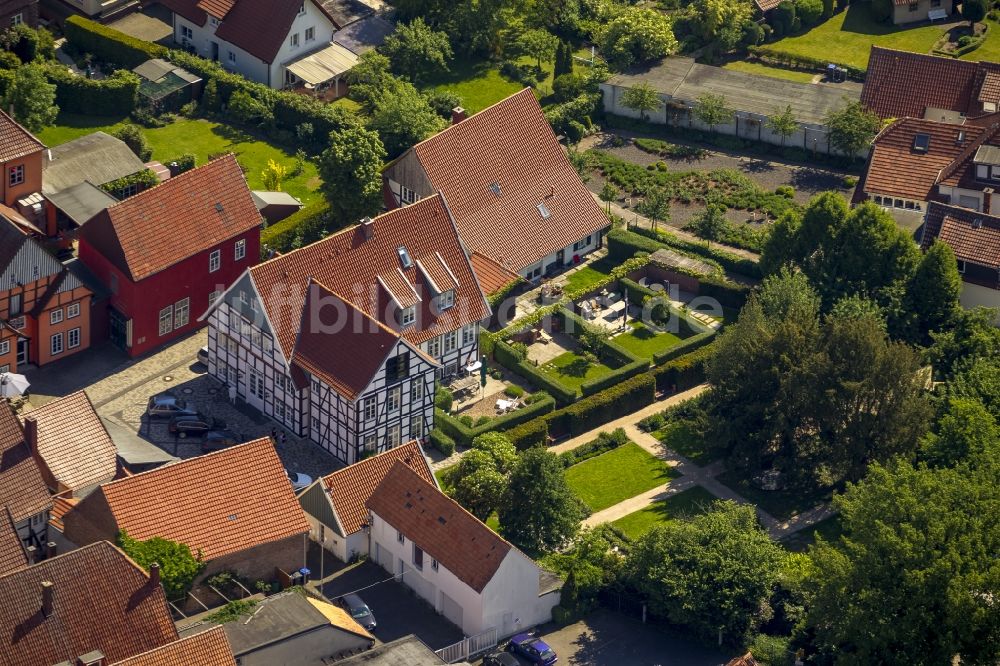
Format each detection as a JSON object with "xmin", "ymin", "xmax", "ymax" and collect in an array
[{"xmin": 545, "ymin": 372, "xmax": 656, "ymax": 435}]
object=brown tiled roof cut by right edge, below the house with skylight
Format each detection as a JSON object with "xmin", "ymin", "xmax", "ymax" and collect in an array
[{"xmin": 920, "ymin": 202, "xmax": 1000, "ymax": 269}]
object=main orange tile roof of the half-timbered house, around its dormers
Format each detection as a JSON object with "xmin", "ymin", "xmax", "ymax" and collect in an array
[{"xmin": 250, "ymin": 196, "xmax": 490, "ymax": 366}]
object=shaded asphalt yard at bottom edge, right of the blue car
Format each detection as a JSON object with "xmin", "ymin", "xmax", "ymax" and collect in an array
[{"xmin": 542, "ymin": 609, "xmax": 732, "ymax": 666}]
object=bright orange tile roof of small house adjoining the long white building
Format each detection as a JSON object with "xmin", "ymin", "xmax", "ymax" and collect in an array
[{"xmin": 322, "ymin": 442, "xmax": 436, "ymax": 536}]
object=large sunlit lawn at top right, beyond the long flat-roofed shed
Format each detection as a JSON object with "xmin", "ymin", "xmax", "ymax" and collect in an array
[{"xmin": 772, "ymin": 2, "xmax": 952, "ymax": 67}]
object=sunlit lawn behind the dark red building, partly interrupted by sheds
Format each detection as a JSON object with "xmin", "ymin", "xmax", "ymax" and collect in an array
[{"xmin": 37, "ymin": 114, "xmax": 320, "ymax": 203}]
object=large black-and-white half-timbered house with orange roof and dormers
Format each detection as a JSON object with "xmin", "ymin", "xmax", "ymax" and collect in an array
[{"xmin": 202, "ymin": 195, "xmax": 490, "ymax": 463}]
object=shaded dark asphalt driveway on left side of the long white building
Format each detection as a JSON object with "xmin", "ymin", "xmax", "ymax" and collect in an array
[{"xmin": 323, "ymin": 562, "xmax": 463, "ymax": 650}]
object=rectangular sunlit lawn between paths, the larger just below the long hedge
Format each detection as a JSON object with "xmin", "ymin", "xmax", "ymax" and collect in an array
[{"xmin": 566, "ymin": 442, "xmax": 677, "ymax": 512}]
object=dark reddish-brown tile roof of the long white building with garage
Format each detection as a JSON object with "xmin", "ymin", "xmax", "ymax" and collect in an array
[{"xmin": 366, "ymin": 461, "xmax": 513, "ymax": 593}]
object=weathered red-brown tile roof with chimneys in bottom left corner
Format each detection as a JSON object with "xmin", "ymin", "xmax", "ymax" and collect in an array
[{"xmin": 0, "ymin": 541, "xmax": 177, "ymax": 666}]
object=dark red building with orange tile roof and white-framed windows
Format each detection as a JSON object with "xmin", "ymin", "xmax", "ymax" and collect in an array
[{"xmin": 79, "ymin": 155, "xmax": 261, "ymax": 356}]
